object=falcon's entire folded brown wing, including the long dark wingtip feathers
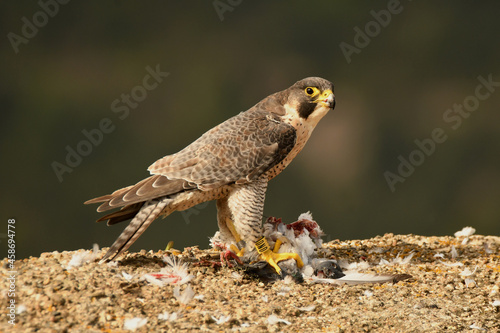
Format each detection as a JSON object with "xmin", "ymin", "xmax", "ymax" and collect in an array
[{"xmin": 85, "ymin": 108, "xmax": 296, "ymax": 219}]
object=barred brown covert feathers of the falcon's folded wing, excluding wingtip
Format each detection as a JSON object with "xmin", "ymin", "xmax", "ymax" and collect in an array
[{"xmin": 148, "ymin": 108, "xmax": 296, "ymax": 190}]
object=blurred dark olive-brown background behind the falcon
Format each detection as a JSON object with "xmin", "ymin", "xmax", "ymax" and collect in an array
[{"xmin": 0, "ymin": 0, "xmax": 500, "ymax": 257}]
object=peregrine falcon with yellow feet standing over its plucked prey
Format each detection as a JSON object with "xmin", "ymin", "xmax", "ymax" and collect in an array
[{"xmin": 85, "ymin": 77, "xmax": 335, "ymax": 272}]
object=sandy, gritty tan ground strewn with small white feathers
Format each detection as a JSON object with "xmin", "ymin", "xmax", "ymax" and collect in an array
[{"xmin": 0, "ymin": 234, "xmax": 500, "ymax": 332}]
